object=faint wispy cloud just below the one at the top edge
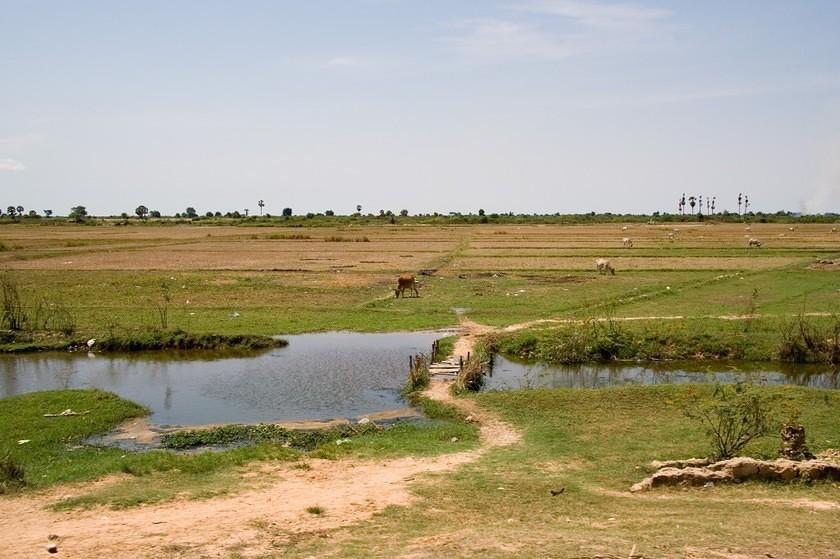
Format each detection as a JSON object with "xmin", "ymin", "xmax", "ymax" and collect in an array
[{"xmin": 446, "ymin": 19, "xmax": 573, "ymax": 60}]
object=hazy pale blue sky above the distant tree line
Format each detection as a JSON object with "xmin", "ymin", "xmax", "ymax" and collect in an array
[{"xmin": 0, "ymin": 0, "xmax": 840, "ymax": 214}]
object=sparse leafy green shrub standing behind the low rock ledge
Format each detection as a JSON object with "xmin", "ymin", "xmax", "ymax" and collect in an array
[{"xmin": 685, "ymin": 383, "xmax": 781, "ymax": 460}]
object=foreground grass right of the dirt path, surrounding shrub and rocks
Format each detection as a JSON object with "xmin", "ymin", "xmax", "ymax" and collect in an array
[{"xmin": 266, "ymin": 386, "xmax": 840, "ymax": 559}]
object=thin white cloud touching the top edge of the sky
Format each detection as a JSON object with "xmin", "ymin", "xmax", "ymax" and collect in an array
[{"xmin": 515, "ymin": 0, "xmax": 672, "ymax": 29}]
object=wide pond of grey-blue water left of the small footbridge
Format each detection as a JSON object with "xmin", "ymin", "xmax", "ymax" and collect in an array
[{"xmin": 0, "ymin": 332, "xmax": 446, "ymax": 425}]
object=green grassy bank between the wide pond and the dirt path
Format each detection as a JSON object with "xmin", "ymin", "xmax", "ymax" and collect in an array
[{"xmin": 0, "ymin": 390, "xmax": 477, "ymax": 507}]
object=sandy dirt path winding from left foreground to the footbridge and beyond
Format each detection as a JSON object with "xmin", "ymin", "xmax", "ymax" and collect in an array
[{"xmin": 0, "ymin": 323, "xmax": 521, "ymax": 559}]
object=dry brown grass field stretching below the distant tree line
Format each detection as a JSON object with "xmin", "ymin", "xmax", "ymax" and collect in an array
[{"xmin": 0, "ymin": 224, "xmax": 840, "ymax": 273}]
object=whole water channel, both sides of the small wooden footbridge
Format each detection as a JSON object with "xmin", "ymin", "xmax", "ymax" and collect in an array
[{"xmin": 0, "ymin": 331, "xmax": 840, "ymax": 426}]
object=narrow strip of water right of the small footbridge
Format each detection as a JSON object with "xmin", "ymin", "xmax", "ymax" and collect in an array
[{"xmin": 484, "ymin": 355, "xmax": 840, "ymax": 390}]
